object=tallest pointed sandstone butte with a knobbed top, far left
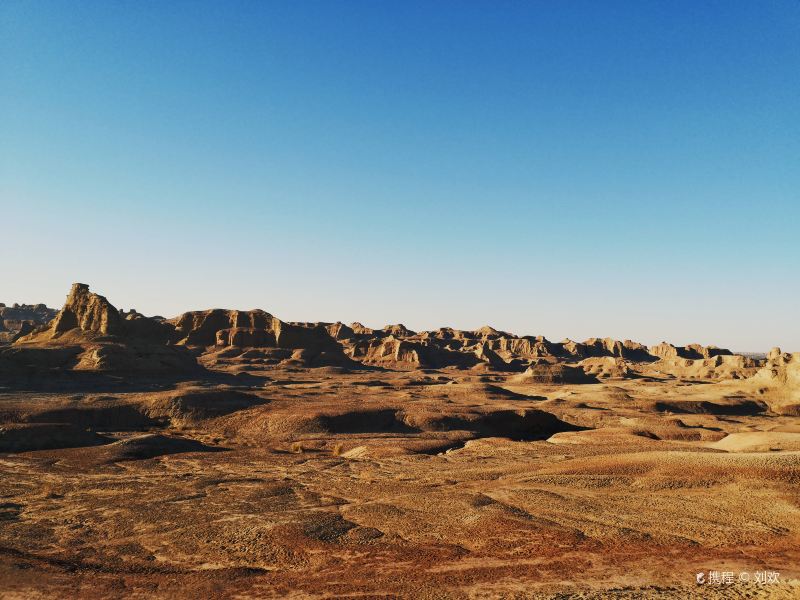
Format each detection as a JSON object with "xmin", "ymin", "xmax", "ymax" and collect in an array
[{"xmin": 50, "ymin": 283, "xmax": 123, "ymax": 337}]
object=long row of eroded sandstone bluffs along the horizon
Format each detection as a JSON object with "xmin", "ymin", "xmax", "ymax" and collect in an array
[{"xmin": 0, "ymin": 283, "xmax": 774, "ymax": 382}]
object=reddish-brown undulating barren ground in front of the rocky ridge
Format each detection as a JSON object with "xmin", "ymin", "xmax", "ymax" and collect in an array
[{"xmin": 0, "ymin": 370, "xmax": 800, "ymax": 598}]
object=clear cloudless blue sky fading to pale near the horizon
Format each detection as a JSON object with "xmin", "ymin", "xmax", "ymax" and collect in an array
[{"xmin": 0, "ymin": 0, "xmax": 800, "ymax": 351}]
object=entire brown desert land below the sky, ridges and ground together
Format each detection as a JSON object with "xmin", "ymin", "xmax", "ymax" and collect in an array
[{"xmin": 0, "ymin": 284, "xmax": 800, "ymax": 598}]
